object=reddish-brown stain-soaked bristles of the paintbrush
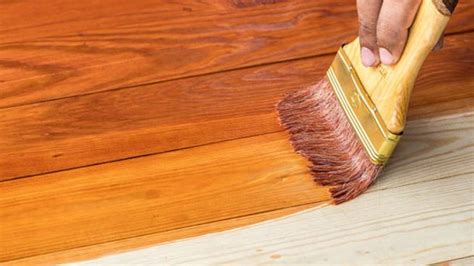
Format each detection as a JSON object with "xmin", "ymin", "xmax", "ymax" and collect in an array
[{"xmin": 277, "ymin": 79, "xmax": 382, "ymax": 204}]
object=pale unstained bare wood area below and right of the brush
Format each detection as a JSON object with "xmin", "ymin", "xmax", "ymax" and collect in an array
[{"xmin": 71, "ymin": 113, "xmax": 474, "ymax": 265}]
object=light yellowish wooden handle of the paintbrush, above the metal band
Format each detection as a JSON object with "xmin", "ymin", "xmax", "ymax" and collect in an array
[{"xmin": 344, "ymin": 0, "xmax": 457, "ymax": 134}]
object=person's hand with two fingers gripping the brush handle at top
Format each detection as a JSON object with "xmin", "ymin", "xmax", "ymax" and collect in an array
[{"xmin": 357, "ymin": 0, "xmax": 441, "ymax": 67}]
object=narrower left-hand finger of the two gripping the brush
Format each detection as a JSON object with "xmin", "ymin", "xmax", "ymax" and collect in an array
[{"xmin": 357, "ymin": 0, "xmax": 382, "ymax": 67}]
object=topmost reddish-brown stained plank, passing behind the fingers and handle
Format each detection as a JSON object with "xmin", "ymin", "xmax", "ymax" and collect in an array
[{"xmin": 0, "ymin": 0, "xmax": 474, "ymax": 107}]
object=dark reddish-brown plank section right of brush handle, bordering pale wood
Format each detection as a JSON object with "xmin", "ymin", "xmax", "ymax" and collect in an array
[{"xmin": 408, "ymin": 32, "xmax": 474, "ymax": 117}]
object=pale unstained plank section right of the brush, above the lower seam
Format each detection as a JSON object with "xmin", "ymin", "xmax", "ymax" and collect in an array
[{"xmin": 374, "ymin": 112, "xmax": 474, "ymax": 189}]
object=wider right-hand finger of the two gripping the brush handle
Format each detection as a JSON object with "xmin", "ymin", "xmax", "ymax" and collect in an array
[{"xmin": 377, "ymin": 0, "xmax": 421, "ymax": 65}]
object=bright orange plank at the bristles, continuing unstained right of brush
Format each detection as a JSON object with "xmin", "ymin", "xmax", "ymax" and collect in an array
[{"xmin": 0, "ymin": 113, "xmax": 474, "ymax": 261}]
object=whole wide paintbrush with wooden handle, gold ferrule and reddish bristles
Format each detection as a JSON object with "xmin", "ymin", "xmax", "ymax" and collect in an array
[{"xmin": 277, "ymin": 0, "xmax": 457, "ymax": 204}]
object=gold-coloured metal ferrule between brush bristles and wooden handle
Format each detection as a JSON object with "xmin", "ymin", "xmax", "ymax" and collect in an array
[{"xmin": 327, "ymin": 47, "xmax": 401, "ymax": 164}]
